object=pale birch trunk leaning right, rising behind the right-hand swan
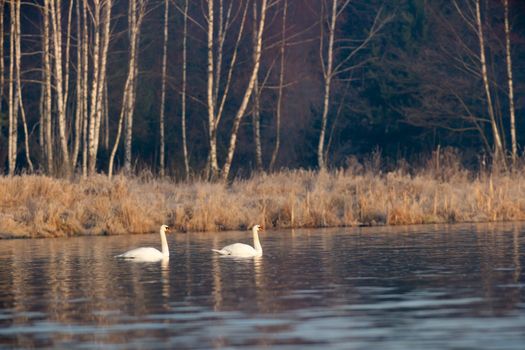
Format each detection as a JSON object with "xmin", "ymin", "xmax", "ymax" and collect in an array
[{"xmin": 221, "ymin": 0, "xmax": 267, "ymax": 180}]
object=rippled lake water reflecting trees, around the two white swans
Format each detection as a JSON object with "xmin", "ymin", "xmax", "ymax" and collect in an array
[{"xmin": 0, "ymin": 223, "xmax": 525, "ymax": 350}]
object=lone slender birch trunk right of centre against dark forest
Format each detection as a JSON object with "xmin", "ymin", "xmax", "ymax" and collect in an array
[{"xmin": 317, "ymin": 0, "xmax": 337, "ymax": 170}]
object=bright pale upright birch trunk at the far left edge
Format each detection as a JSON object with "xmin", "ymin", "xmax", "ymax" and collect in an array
[{"xmin": 8, "ymin": 3, "xmax": 18, "ymax": 176}]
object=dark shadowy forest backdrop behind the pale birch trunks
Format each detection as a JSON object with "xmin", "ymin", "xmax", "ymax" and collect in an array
[{"xmin": 0, "ymin": 0, "xmax": 525, "ymax": 178}]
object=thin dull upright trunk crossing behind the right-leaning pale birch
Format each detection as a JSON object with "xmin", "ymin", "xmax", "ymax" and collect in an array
[{"xmin": 252, "ymin": 1, "xmax": 263, "ymax": 172}]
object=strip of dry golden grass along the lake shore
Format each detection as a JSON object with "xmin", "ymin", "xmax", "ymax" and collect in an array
[{"xmin": 0, "ymin": 169, "xmax": 525, "ymax": 237}]
